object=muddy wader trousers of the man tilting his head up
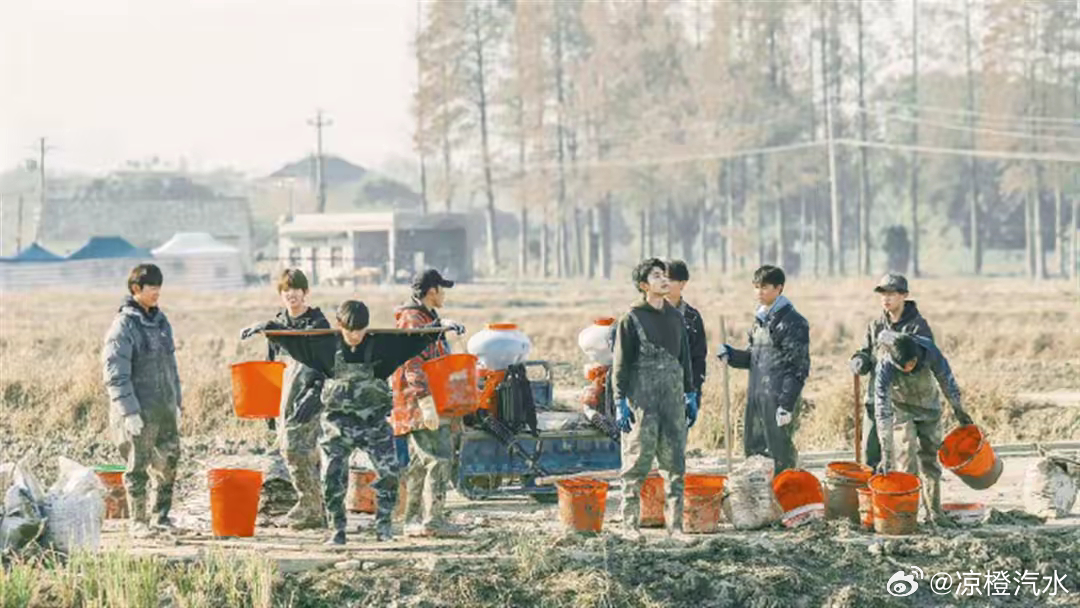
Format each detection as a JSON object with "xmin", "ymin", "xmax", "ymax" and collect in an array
[{"xmin": 621, "ymin": 393, "xmax": 687, "ymax": 530}]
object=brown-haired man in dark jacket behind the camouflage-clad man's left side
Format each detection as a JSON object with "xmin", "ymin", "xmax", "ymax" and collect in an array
[{"xmin": 240, "ymin": 268, "xmax": 330, "ymax": 530}]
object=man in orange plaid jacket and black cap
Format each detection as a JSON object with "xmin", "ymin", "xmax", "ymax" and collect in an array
[{"xmin": 392, "ymin": 269, "xmax": 464, "ymax": 536}]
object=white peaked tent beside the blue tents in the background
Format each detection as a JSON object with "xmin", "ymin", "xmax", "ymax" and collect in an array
[{"xmin": 151, "ymin": 232, "xmax": 244, "ymax": 289}]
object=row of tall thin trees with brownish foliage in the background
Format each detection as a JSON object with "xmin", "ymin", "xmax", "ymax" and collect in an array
[{"xmin": 414, "ymin": 0, "xmax": 1080, "ymax": 276}]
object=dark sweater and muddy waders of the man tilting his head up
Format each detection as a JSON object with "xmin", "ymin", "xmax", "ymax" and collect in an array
[{"xmin": 612, "ymin": 302, "xmax": 693, "ymax": 530}]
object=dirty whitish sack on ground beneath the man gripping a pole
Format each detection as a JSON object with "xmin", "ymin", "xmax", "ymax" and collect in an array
[{"xmin": 721, "ymin": 456, "xmax": 781, "ymax": 530}]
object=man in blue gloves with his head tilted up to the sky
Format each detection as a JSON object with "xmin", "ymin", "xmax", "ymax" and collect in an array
[{"xmin": 611, "ymin": 258, "xmax": 698, "ymax": 539}]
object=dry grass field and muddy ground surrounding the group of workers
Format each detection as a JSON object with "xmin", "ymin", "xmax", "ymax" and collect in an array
[{"xmin": 0, "ymin": 278, "xmax": 1080, "ymax": 607}]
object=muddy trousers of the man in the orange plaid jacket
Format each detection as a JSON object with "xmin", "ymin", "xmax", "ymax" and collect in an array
[{"xmin": 405, "ymin": 424, "xmax": 454, "ymax": 526}]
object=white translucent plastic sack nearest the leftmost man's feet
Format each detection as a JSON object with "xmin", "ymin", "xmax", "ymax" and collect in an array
[{"xmin": 45, "ymin": 457, "xmax": 105, "ymax": 553}]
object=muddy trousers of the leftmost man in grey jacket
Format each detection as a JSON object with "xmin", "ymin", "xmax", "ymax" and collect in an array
[{"xmin": 119, "ymin": 411, "xmax": 180, "ymax": 524}]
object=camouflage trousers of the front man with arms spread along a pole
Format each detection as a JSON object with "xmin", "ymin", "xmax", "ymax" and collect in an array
[{"xmin": 319, "ymin": 411, "xmax": 399, "ymax": 530}]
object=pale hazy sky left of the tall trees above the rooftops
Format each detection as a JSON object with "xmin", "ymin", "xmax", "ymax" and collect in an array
[{"xmin": 0, "ymin": 0, "xmax": 416, "ymax": 173}]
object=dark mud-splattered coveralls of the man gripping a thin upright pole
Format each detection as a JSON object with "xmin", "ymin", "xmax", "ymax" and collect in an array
[{"xmin": 729, "ymin": 300, "xmax": 810, "ymax": 473}]
